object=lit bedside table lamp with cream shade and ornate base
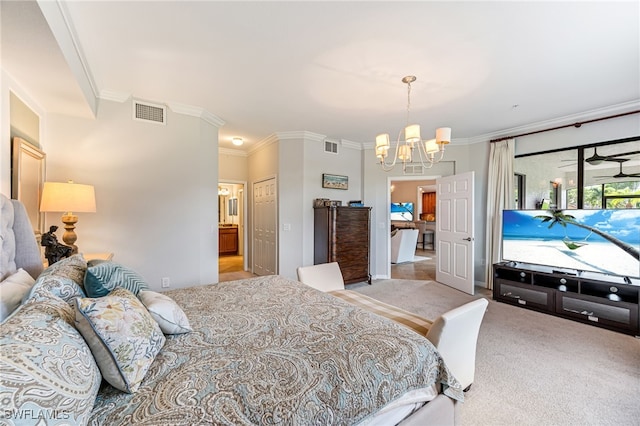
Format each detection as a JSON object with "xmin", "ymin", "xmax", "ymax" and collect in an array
[{"xmin": 40, "ymin": 181, "xmax": 96, "ymax": 254}]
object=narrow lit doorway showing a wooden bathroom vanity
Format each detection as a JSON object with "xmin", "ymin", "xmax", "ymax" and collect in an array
[{"xmin": 218, "ymin": 181, "xmax": 247, "ymax": 280}]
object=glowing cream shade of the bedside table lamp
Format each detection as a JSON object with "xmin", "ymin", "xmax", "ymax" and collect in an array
[{"xmin": 40, "ymin": 182, "xmax": 96, "ymax": 213}]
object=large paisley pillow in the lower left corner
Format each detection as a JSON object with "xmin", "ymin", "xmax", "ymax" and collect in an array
[{"xmin": 0, "ymin": 302, "xmax": 102, "ymax": 426}]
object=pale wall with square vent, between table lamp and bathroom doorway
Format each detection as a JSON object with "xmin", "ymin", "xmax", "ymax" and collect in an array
[{"xmin": 43, "ymin": 101, "xmax": 218, "ymax": 290}]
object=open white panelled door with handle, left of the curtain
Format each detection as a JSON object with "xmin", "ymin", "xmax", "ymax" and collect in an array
[{"xmin": 435, "ymin": 172, "xmax": 474, "ymax": 294}]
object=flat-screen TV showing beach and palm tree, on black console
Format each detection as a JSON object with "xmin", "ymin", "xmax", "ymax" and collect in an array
[{"xmin": 502, "ymin": 209, "xmax": 640, "ymax": 278}]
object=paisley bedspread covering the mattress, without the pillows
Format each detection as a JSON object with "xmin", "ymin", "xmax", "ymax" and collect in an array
[{"xmin": 89, "ymin": 276, "xmax": 462, "ymax": 425}]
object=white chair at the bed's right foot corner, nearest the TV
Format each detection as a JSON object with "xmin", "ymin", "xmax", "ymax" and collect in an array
[{"xmin": 427, "ymin": 298, "xmax": 489, "ymax": 391}]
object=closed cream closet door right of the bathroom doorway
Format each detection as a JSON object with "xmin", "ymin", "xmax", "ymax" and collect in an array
[{"xmin": 252, "ymin": 178, "xmax": 278, "ymax": 275}]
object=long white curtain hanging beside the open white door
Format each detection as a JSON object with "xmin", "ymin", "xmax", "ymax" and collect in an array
[{"xmin": 485, "ymin": 139, "xmax": 522, "ymax": 289}]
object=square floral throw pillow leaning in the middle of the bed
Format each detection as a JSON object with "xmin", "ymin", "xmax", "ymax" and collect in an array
[{"xmin": 75, "ymin": 287, "xmax": 166, "ymax": 393}]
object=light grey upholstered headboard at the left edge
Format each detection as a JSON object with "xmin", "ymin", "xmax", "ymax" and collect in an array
[{"xmin": 0, "ymin": 194, "xmax": 43, "ymax": 281}]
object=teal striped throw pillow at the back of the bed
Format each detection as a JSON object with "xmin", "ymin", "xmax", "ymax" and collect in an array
[{"xmin": 84, "ymin": 262, "xmax": 149, "ymax": 297}]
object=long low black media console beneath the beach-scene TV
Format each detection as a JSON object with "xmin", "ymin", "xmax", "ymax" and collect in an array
[{"xmin": 493, "ymin": 262, "xmax": 640, "ymax": 336}]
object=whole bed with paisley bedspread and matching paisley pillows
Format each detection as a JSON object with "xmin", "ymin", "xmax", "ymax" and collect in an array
[{"xmin": 0, "ymin": 195, "xmax": 463, "ymax": 425}]
